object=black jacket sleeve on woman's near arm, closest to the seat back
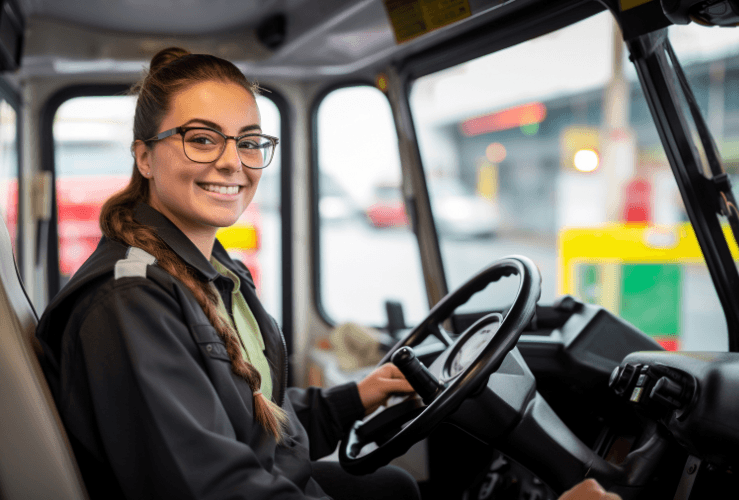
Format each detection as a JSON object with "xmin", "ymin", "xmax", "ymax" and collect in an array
[{"xmin": 77, "ymin": 277, "xmax": 324, "ymax": 500}]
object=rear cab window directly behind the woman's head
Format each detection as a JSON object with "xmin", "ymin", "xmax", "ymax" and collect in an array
[{"xmin": 54, "ymin": 96, "xmax": 282, "ymax": 318}]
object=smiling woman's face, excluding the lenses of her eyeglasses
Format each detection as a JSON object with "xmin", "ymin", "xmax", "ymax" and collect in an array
[{"xmin": 134, "ymin": 81, "xmax": 262, "ymax": 239}]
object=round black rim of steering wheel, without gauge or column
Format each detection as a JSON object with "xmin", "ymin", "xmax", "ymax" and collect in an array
[{"xmin": 339, "ymin": 255, "xmax": 541, "ymax": 474}]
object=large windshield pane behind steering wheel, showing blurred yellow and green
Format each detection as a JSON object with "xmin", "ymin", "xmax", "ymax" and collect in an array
[{"xmin": 411, "ymin": 13, "xmax": 728, "ymax": 350}]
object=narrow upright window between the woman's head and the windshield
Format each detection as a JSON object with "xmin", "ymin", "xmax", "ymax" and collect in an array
[{"xmin": 317, "ymin": 86, "xmax": 428, "ymax": 326}]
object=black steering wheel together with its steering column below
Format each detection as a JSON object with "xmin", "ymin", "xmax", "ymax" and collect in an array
[{"xmin": 339, "ymin": 255, "xmax": 669, "ymax": 500}]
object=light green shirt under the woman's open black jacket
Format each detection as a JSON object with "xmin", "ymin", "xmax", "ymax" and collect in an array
[{"xmin": 210, "ymin": 258, "xmax": 272, "ymax": 399}]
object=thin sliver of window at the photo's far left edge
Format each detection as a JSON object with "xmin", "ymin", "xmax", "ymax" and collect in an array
[{"xmin": 0, "ymin": 98, "xmax": 18, "ymax": 261}]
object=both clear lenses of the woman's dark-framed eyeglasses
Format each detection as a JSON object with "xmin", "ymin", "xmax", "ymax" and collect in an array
[{"xmin": 183, "ymin": 129, "xmax": 274, "ymax": 168}]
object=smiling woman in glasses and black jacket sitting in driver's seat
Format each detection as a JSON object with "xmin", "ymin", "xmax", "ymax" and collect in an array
[{"xmin": 37, "ymin": 48, "xmax": 418, "ymax": 499}]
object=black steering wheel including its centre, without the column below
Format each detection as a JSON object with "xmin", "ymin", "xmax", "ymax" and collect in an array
[{"xmin": 339, "ymin": 255, "xmax": 541, "ymax": 474}]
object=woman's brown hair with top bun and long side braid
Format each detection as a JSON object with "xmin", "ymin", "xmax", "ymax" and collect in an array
[{"xmin": 100, "ymin": 47, "xmax": 287, "ymax": 442}]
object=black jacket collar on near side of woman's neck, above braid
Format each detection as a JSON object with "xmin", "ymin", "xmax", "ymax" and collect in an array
[{"xmin": 133, "ymin": 202, "xmax": 221, "ymax": 281}]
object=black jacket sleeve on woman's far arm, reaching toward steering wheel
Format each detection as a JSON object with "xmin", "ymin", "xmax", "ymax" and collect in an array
[{"xmin": 287, "ymin": 382, "xmax": 365, "ymax": 460}]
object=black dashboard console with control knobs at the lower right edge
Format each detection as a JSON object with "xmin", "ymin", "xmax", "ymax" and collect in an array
[{"xmin": 609, "ymin": 351, "xmax": 739, "ymax": 499}]
